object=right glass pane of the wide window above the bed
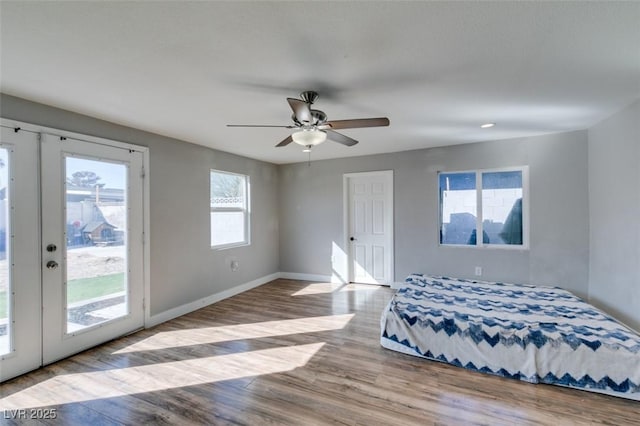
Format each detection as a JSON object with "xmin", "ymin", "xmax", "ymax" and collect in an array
[{"xmin": 482, "ymin": 171, "xmax": 522, "ymax": 245}]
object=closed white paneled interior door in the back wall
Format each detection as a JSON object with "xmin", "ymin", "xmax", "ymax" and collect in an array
[{"xmin": 345, "ymin": 171, "xmax": 393, "ymax": 284}]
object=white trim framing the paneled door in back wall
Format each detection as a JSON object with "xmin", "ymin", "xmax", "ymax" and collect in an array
[{"xmin": 342, "ymin": 170, "xmax": 396, "ymax": 284}]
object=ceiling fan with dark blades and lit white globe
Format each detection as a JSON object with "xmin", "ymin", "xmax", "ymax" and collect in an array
[{"xmin": 227, "ymin": 90, "xmax": 389, "ymax": 152}]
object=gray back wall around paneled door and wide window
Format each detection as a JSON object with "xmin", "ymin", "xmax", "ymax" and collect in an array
[{"xmin": 280, "ymin": 131, "xmax": 589, "ymax": 298}]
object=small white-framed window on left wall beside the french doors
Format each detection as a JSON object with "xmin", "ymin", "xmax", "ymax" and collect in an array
[{"xmin": 211, "ymin": 170, "xmax": 249, "ymax": 248}]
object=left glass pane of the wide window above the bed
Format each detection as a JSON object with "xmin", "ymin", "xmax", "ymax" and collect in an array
[{"xmin": 439, "ymin": 172, "xmax": 477, "ymax": 245}]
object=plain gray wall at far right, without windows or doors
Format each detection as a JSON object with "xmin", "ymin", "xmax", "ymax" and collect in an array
[{"xmin": 589, "ymin": 100, "xmax": 640, "ymax": 330}]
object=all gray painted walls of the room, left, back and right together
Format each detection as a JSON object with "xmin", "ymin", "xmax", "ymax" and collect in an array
[{"xmin": 7, "ymin": 95, "xmax": 640, "ymax": 328}]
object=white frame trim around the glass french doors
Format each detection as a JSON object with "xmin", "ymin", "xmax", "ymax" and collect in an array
[{"xmin": 0, "ymin": 117, "xmax": 151, "ymax": 327}]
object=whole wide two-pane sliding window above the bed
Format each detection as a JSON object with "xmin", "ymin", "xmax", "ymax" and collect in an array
[{"xmin": 438, "ymin": 167, "xmax": 529, "ymax": 248}]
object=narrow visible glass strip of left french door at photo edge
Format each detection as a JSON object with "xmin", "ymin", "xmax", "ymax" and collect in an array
[{"xmin": 0, "ymin": 148, "xmax": 12, "ymax": 356}]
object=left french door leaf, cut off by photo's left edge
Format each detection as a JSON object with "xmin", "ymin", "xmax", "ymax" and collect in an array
[{"xmin": 0, "ymin": 126, "xmax": 42, "ymax": 381}]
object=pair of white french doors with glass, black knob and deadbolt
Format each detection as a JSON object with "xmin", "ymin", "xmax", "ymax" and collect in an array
[{"xmin": 0, "ymin": 120, "xmax": 145, "ymax": 381}]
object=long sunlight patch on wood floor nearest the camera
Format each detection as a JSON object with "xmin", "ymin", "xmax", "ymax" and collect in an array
[{"xmin": 0, "ymin": 342, "xmax": 325, "ymax": 411}]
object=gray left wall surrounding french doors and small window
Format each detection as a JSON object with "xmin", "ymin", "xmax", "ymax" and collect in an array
[{"xmin": 0, "ymin": 94, "xmax": 279, "ymax": 315}]
